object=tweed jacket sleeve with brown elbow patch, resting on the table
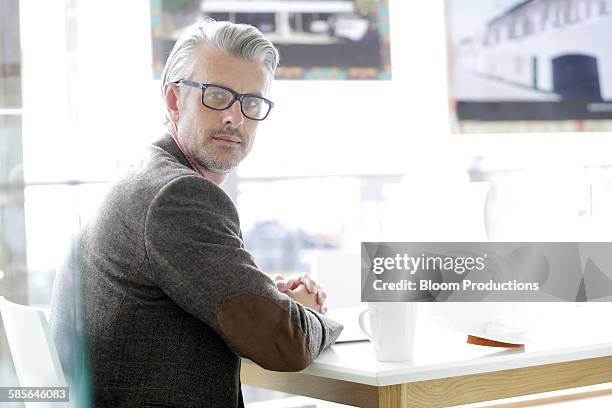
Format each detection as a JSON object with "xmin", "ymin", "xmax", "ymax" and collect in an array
[{"xmin": 144, "ymin": 175, "xmax": 342, "ymax": 371}]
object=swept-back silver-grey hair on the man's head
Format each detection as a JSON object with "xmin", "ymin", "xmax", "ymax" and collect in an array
[{"xmin": 161, "ymin": 18, "xmax": 279, "ymax": 99}]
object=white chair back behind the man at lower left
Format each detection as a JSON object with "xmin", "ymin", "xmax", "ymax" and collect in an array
[{"xmin": 0, "ymin": 296, "xmax": 68, "ymax": 408}]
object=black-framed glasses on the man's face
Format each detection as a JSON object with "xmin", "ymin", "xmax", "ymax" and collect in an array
[{"xmin": 174, "ymin": 79, "xmax": 274, "ymax": 120}]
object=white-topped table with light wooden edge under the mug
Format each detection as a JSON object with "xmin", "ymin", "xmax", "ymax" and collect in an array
[{"xmin": 241, "ymin": 304, "xmax": 612, "ymax": 408}]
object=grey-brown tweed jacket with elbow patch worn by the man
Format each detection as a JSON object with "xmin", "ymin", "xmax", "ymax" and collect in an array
[{"xmin": 50, "ymin": 135, "xmax": 342, "ymax": 408}]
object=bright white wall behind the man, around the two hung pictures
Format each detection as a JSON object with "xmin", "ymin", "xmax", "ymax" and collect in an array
[{"xmin": 21, "ymin": 0, "xmax": 611, "ymax": 181}]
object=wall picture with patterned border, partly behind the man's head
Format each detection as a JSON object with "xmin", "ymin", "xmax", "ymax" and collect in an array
[{"xmin": 151, "ymin": 0, "xmax": 391, "ymax": 80}]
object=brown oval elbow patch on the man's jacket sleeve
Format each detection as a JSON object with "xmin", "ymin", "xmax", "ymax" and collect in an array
[{"xmin": 217, "ymin": 293, "xmax": 311, "ymax": 371}]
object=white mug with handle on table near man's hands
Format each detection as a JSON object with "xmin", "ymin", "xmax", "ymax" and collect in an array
[{"xmin": 359, "ymin": 302, "xmax": 417, "ymax": 361}]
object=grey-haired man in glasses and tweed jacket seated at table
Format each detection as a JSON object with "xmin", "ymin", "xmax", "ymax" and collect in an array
[{"xmin": 51, "ymin": 21, "xmax": 342, "ymax": 408}]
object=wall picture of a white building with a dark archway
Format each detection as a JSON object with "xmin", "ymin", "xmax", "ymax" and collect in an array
[{"xmin": 446, "ymin": 0, "xmax": 612, "ymax": 132}]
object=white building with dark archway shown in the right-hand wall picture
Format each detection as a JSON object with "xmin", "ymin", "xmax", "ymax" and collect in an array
[{"xmin": 454, "ymin": 0, "xmax": 612, "ymax": 101}]
